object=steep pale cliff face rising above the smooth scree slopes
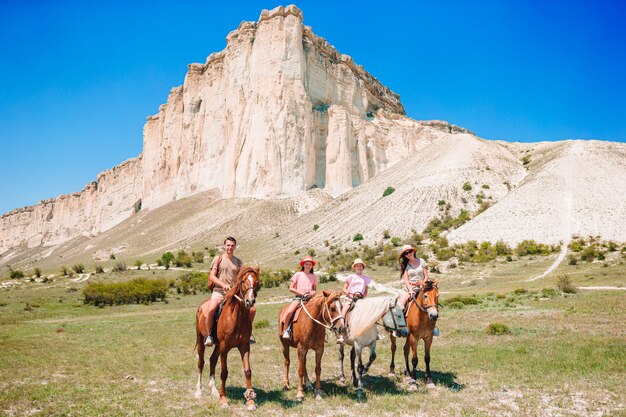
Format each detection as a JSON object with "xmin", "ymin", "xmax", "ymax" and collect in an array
[{"xmin": 0, "ymin": 6, "xmax": 464, "ymax": 253}]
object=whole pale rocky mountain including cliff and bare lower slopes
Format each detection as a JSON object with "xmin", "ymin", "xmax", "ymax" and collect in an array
[{"xmin": 0, "ymin": 6, "xmax": 626, "ymax": 270}]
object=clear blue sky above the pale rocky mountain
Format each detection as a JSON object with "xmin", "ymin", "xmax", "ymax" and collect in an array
[{"xmin": 0, "ymin": 0, "xmax": 626, "ymax": 213}]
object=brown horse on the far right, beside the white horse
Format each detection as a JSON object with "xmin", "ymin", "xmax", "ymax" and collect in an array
[{"xmin": 389, "ymin": 279, "xmax": 439, "ymax": 389}]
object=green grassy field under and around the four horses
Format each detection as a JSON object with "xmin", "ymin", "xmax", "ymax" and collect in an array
[{"xmin": 0, "ymin": 255, "xmax": 626, "ymax": 416}]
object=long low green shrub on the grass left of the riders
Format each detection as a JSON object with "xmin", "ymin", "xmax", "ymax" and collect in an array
[{"xmin": 83, "ymin": 278, "xmax": 169, "ymax": 307}]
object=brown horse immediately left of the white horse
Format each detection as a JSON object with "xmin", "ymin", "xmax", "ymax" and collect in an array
[{"xmin": 278, "ymin": 291, "xmax": 344, "ymax": 401}]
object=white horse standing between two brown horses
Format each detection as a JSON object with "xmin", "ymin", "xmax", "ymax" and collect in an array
[{"xmin": 339, "ymin": 296, "xmax": 408, "ymax": 397}]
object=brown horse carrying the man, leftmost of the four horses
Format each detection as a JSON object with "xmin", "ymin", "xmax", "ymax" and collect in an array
[{"xmin": 196, "ymin": 266, "xmax": 259, "ymax": 410}]
